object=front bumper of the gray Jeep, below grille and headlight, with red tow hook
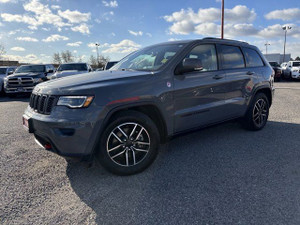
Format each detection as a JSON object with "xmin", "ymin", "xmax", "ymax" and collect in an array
[{"xmin": 23, "ymin": 106, "xmax": 101, "ymax": 158}]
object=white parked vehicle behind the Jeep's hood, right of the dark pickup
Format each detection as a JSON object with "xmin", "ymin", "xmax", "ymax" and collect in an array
[{"xmin": 51, "ymin": 63, "xmax": 93, "ymax": 79}]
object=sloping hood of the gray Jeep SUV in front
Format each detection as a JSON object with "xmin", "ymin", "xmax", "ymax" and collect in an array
[{"xmin": 34, "ymin": 70, "xmax": 153, "ymax": 95}]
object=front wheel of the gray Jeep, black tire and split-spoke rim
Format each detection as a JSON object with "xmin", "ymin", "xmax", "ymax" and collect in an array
[{"xmin": 96, "ymin": 110, "xmax": 159, "ymax": 175}]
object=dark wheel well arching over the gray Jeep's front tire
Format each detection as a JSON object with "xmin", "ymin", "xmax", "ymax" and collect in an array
[{"xmin": 106, "ymin": 105, "xmax": 168, "ymax": 143}]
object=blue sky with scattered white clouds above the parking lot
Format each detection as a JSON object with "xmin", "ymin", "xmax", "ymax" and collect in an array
[{"xmin": 0, "ymin": 0, "xmax": 300, "ymax": 63}]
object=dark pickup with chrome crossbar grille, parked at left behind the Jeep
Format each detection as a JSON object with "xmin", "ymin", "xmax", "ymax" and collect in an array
[{"xmin": 4, "ymin": 64, "xmax": 55, "ymax": 96}]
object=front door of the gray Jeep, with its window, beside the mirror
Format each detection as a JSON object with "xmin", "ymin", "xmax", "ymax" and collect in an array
[{"xmin": 173, "ymin": 44, "xmax": 225, "ymax": 133}]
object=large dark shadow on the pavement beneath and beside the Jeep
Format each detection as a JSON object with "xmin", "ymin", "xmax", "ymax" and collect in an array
[{"xmin": 67, "ymin": 121, "xmax": 300, "ymax": 224}]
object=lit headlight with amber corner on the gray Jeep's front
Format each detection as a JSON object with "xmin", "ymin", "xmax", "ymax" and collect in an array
[{"xmin": 57, "ymin": 96, "xmax": 94, "ymax": 108}]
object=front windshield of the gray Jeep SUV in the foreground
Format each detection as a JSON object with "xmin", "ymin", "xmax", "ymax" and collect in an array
[{"xmin": 110, "ymin": 44, "xmax": 184, "ymax": 71}]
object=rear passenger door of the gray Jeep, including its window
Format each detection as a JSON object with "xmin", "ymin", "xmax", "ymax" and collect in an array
[{"xmin": 218, "ymin": 45, "xmax": 256, "ymax": 119}]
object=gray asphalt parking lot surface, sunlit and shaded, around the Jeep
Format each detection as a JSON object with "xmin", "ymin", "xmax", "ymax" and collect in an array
[{"xmin": 0, "ymin": 82, "xmax": 300, "ymax": 224}]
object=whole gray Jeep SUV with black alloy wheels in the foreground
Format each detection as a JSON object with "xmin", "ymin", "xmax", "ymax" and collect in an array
[{"xmin": 23, "ymin": 38, "xmax": 274, "ymax": 175}]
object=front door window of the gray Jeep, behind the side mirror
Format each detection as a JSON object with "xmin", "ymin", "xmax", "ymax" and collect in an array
[{"xmin": 185, "ymin": 44, "xmax": 218, "ymax": 71}]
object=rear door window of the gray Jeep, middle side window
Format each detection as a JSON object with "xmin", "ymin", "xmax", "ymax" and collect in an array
[{"xmin": 221, "ymin": 45, "xmax": 245, "ymax": 69}]
